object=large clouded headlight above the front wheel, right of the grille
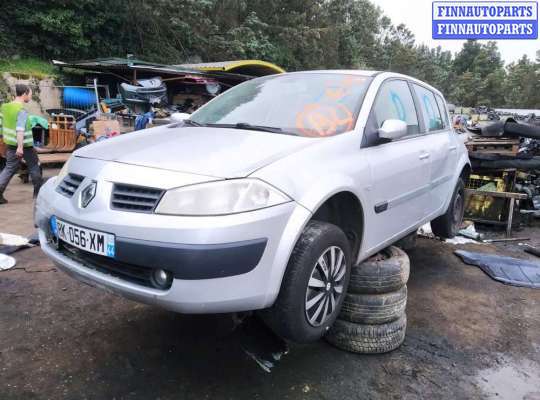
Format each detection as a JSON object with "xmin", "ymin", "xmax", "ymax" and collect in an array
[{"xmin": 156, "ymin": 179, "xmax": 291, "ymax": 215}]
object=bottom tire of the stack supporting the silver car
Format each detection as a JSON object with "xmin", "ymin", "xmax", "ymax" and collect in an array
[{"xmin": 326, "ymin": 313, "xmax": 407, "ymax": 354}]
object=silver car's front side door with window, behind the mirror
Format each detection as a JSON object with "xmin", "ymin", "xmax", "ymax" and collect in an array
[{"xmin": 362, "ymin": 79, "xmax": 430, "ymax": 249}]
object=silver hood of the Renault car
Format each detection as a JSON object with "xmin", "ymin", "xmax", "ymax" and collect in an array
[{"xmin": 75, "ymin": 126, "xmax": 317, "ymax": 178}]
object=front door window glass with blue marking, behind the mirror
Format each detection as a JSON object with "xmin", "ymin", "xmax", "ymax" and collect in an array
[{"xmin": 373, "ymin": 80, "xmax": 420, "ymax": 135}]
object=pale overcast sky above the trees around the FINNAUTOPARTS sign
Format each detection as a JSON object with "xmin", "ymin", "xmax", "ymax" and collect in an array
[{"xmin": 371, "ymin": 0, "xmax": 540, "ymax": 64}]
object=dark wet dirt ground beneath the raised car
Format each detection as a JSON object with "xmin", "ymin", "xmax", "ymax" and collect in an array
[{"xmin": 0, "ymin": 167, "xmax": 540, "ymax": 400}]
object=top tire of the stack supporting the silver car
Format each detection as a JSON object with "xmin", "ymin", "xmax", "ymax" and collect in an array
[{"xmin": 349, "ymin": 246, "xmax": 410, "ymax": 294}]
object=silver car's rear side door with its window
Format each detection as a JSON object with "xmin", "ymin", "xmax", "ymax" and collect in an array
[{"xmin": 412, "ymin": 83, "xmax": 457, "ymax": 215}]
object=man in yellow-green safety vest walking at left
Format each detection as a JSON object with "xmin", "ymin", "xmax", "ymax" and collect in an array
[{"xmin": 0, "ymin": 84, "xmax": 42, "ymax": 204}]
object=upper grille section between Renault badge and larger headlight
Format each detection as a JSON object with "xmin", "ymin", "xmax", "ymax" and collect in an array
[{"xmin": 111, "ymin": 183, "xmax": 163, "ymax": 212}]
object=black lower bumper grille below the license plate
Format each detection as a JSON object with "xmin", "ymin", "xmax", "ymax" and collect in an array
[{"xmin": 58, "ymin": 242, "xmax": 170, "ymax": 290}]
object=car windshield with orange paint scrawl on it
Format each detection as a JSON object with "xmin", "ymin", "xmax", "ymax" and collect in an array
[{"xmin": 190, "ymin": 72, "xmax": 371, "ymax": 137}]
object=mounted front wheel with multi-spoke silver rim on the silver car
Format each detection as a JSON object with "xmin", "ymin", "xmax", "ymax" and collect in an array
[{"xmin": 259, "ymin": 221, "xmax": 351, "ymax": 343}]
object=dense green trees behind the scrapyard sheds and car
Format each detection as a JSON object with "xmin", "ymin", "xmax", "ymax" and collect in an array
[{"xmin": 0, "ymin": 0, "xmax": 540, "ymax": 108}]
